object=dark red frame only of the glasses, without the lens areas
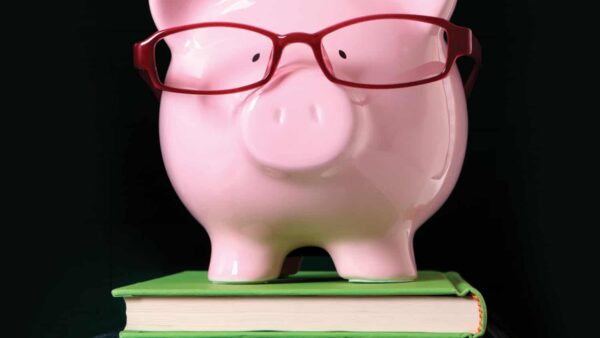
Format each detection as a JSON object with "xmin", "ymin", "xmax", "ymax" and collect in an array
[{"xmin": 133, "ymin": 14, "xmax": 481, "ymax": 99}]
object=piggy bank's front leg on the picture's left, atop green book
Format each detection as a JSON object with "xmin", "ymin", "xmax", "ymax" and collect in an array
[{"xmin": 208, "ymin": 234, "xmax": 289, "ymax": 283}]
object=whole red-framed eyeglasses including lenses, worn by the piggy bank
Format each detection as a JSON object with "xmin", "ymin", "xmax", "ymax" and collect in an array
[{"xmin": 134, "ymin": 14, "xmax": 481, "ymax": 97}]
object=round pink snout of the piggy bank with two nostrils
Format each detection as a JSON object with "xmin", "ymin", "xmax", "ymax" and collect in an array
[{"xmin": 241, "ymin": 67, "xmax": 355, "ymax": 172}]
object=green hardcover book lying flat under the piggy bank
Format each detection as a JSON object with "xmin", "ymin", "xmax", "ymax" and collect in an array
[{"xmin": 112, "ymin": 271, "xmax": 487, "ymax": 338}]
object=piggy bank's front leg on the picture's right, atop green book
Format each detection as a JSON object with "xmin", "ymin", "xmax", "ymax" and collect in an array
[{"xmin": 325, "ymin": 229, "xmax": 417, "ymax": 283}]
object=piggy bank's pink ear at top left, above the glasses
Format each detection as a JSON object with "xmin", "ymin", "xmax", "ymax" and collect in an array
[{"xmin": 150, "ymin": 0, "xmax": 207, "ymax": 30}]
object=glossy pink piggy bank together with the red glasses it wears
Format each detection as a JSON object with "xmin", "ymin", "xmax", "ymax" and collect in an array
[{"xmin": 135, "ymin": 0, "xmax": 478, "ymax": 283}]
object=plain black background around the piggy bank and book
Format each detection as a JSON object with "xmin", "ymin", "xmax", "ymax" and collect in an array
[{"xmin": 2, "ymin": 0, "xmax": 599, "ymax": 337}]
